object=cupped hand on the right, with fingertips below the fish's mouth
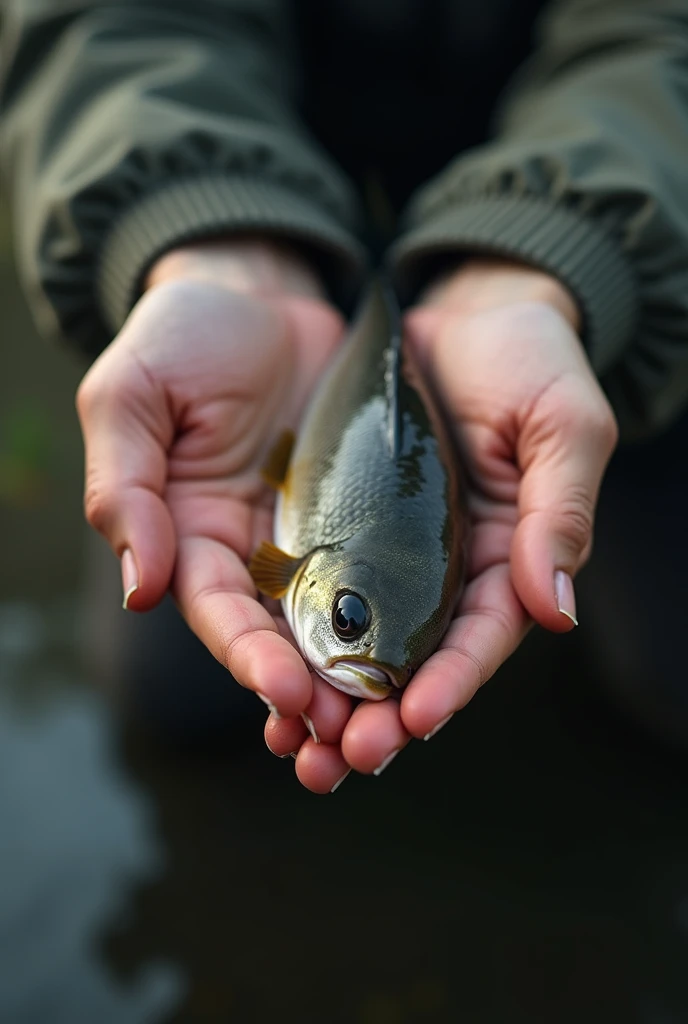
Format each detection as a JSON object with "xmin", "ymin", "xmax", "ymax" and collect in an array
[{"xmin": 265, "ymin": 260, "xmax": 616, "ymax": 793}]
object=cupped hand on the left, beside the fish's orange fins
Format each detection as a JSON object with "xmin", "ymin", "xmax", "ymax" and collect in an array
[{"xmin": 77, "ymin": 242, "xmax": 343, "ymax": 720}]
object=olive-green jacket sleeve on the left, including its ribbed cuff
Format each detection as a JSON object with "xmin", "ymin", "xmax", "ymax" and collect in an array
[{"xmin": 0, "ymin": 0, "xmax": 363, "ymax": 354}]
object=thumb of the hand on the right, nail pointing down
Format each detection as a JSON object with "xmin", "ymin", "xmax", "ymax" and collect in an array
[{"xmin": 511, "ymin": 373, "xmax": 617, "ymax": 633}]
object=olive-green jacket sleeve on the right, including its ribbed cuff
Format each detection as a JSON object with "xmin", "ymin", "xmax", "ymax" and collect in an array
[{"xmin": 391, "ymin": 0, "xmax": 688, "ymax": 437}]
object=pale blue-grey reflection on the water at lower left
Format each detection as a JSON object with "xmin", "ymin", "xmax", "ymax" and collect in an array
[{"xmin": 0, "ymin": 604, "xmax": 183, "ymax": 1024}]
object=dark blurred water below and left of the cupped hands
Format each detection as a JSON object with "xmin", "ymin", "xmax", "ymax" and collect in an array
[{"xmin": 0, "ymin": 201, "xmax": 688, "ymax": 1024}]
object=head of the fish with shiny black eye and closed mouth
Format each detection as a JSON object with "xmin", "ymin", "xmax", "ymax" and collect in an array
[{"xmin": 288, "ymin": 550, "xmax": 446, "ymax": 700}]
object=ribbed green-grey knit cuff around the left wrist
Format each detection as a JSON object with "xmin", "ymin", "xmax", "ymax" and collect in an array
[{"xmin": 96, "ymin": 174, "xmax": 366, "ymax": 333}]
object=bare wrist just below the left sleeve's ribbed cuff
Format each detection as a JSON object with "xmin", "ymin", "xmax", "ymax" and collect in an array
[{"xmin": 144, "ymin": 238, "xmax": 327, "ymax": 300}]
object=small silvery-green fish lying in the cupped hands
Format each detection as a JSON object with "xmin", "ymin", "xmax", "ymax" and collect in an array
[{"xmin": 249, "ymin": 278, "xmax": 468, "ymax": 700}]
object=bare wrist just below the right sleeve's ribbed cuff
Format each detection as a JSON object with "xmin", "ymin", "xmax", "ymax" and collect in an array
[{"xmin": 421, "ymin": 258, "xmax": 582, "ymax": 333}]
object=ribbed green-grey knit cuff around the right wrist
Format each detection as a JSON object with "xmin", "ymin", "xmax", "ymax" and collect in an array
[{"xmin": 390, "ymin": 196, "xmax": 638, "ymax": 373}]
